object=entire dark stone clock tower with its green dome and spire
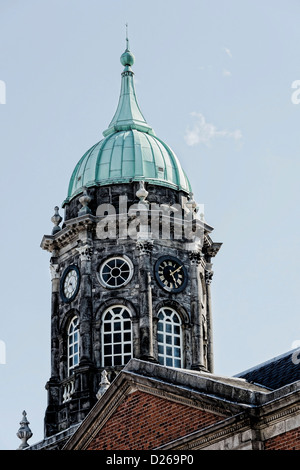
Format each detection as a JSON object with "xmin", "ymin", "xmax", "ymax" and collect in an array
[{"xmin": 41, "ymin": 42, "xmax": 221, "ymax": 437}]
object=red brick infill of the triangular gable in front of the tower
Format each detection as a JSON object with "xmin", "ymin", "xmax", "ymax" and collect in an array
[{"xmin": 87, "ymin": 391, "xmax": 224, "ymax": 450}]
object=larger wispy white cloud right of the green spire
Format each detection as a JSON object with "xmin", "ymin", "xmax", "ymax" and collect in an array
[{"xmin": 184, "ymin": 112, "xmax": 242, "ymax": 146}]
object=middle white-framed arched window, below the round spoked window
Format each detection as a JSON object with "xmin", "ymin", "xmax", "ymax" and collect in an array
[{"xmin": 102, "ymin": 305, "xmax": 132, "ymax": 367}]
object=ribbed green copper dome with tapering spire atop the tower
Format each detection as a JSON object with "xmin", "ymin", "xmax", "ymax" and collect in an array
[{"xmin": 63, "ymin": 47, "xmax": 191, "ymax": 205}]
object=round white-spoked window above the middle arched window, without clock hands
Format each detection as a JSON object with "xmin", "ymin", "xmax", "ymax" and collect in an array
[{"xmin": 99, "ymin": 256, "xmax": 133, "ymax": 289}]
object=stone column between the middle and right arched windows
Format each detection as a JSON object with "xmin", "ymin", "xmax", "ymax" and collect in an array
[{"xmin": 136, "ymin": 240, "xmax": 154, "ymax": 361}]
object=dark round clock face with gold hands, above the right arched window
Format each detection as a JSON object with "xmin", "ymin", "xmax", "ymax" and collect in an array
[{"xmin": 155, "ymin": 256, "xmax": 187, "ymax": 292}]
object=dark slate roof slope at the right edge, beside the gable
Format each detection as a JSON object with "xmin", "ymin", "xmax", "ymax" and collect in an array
[{"xmin": 235, "ymin": 348, "xmax": 300, "ymax": 390}]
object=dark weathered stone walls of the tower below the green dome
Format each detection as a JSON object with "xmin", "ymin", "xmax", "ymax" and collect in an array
[{"xmin": 42, "ymin": 183, "xmax": 221, "ymax": 436}]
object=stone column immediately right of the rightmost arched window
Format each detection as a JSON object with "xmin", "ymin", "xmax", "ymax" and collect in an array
[{"xmin": 189, "ymin": 251, "xmax": 206, "ymax": 370}]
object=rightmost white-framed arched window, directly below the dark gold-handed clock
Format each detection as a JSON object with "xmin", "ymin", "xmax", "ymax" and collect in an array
[{"xmin": 157, "ymin": 307, "xmax": 182, "ymax": 367}]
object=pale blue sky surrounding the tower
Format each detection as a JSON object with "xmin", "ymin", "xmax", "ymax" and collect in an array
[{"xmin": 0, "ymin": 0, "xmax": 300, "ymax": 449}]
